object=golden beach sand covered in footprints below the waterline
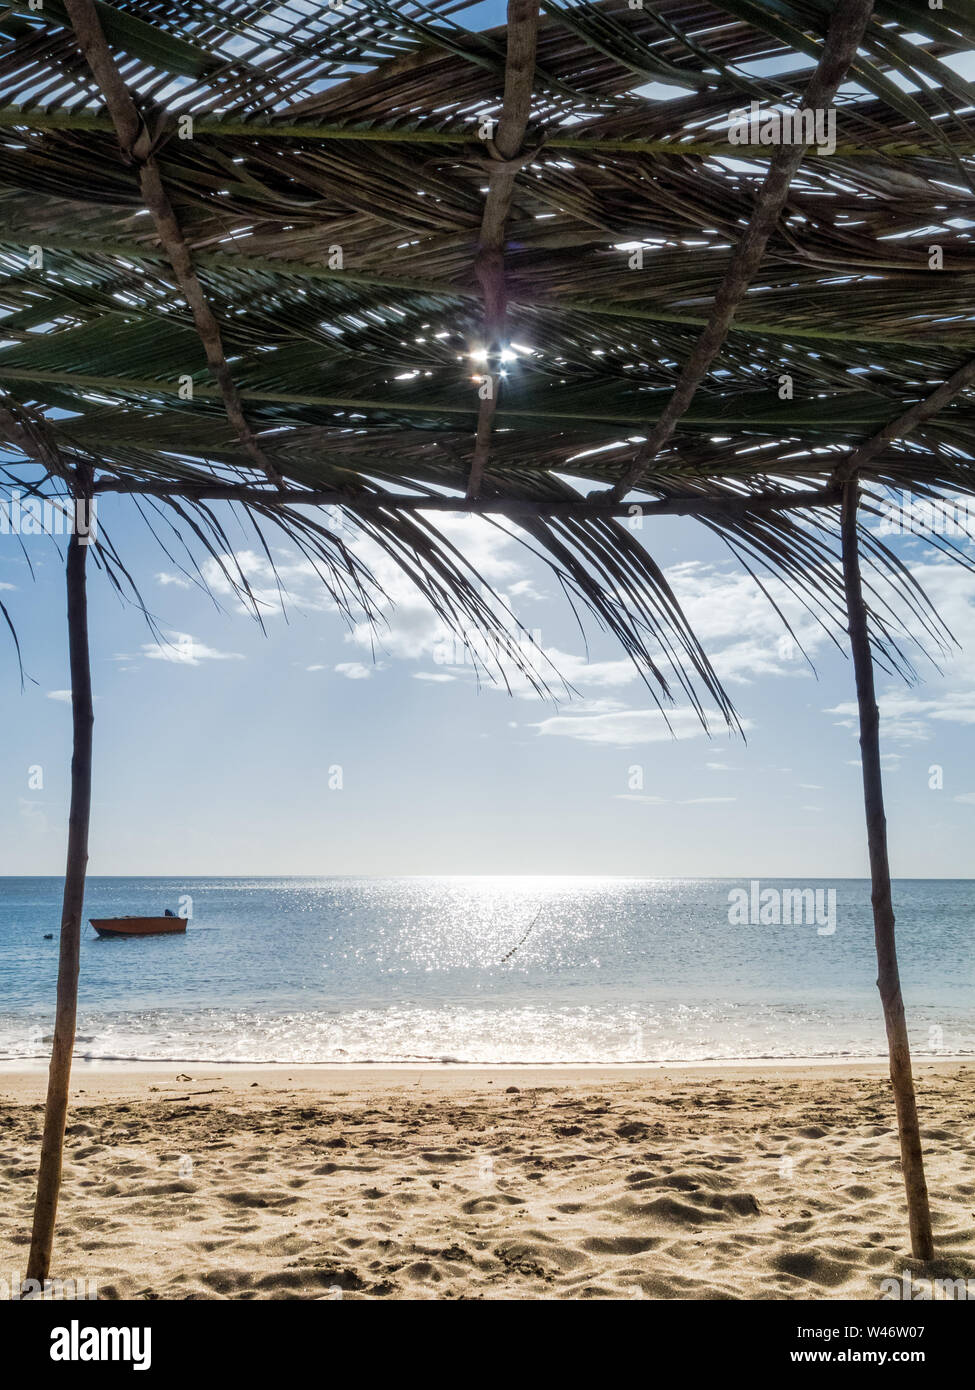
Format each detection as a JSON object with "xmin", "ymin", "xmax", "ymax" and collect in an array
[{"xmin": 0, "ymin": 1062, "xmax": 975, "ymax": 1300}]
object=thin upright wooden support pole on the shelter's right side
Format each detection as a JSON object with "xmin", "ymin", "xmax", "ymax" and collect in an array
[{"xmin": 841, "ymin": 478, "xmax": 935, "ymax": 1261}]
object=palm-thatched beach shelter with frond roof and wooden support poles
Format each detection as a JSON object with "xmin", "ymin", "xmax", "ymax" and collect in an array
[{"xmin": 0, "ymin": 0, "xmax": 975, "ymax": 1277}]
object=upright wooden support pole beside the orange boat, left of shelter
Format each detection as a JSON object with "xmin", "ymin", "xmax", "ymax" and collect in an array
[{"xmin": 26, "ymin": 519, "xmax": 95, "ymax": 1284}]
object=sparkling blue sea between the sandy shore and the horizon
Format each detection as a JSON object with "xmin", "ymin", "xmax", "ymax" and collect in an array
[{"xmin": 0, "ymin": 877, "xmax": 975, "ymax": 1063}]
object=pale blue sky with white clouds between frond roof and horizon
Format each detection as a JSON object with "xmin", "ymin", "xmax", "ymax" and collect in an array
[{"xmin": 0, "ymin": 499, "xmax": 975, "ymax": 876}]
